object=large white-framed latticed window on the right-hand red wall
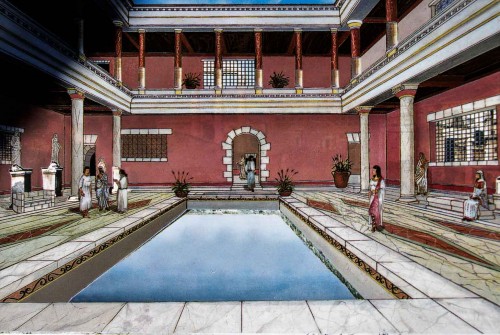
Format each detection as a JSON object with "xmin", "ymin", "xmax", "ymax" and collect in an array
[{"xmin": 436, "ymin": 109, "xmax": 498, "ymax": 162}]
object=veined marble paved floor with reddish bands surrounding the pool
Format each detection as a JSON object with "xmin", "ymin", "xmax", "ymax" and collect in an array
[{"xmin": 0, "ymin": 188, "xmax": 500, "ymax": 334}]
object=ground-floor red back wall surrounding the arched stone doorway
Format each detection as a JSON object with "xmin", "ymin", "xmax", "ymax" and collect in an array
[{"xmin": 117, "ymin": 115, "xmax": 359, "ymax": 184}]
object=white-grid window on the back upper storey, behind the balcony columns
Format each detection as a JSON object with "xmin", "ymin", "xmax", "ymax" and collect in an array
[{"xmin": 203, "ymin": 59, "xmax": 255, "ymax": 88}]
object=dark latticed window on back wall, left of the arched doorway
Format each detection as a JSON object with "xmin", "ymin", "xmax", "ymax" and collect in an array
[{"xmin": 122, "ymin": 134, "xmax": 167, "ymax": 162}]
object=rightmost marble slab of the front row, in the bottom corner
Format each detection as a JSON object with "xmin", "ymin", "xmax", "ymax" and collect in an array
[{"xmin": 435, "ymin": 298, "xmax": 500, "ymax": 334}]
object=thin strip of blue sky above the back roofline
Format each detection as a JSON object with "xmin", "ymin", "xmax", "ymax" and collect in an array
[{"xmin": 133, "ymin": 0, "xmax": 336, "ymax": 5}]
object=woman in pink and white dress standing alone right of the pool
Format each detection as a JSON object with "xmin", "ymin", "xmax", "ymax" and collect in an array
[{"xmin": 368, "ymin": 165, "xmax": 385, "ymax": 231}]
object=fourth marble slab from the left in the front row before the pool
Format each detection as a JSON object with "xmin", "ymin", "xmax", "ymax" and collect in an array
[{"xmin": 175, "ymin": 301, "xmax": 241, "ymax": 333}]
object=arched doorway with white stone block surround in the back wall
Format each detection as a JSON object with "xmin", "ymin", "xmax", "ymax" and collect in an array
[{"xmin": 222, "ymin": 126, "xmax": 271, "ymax": 184}]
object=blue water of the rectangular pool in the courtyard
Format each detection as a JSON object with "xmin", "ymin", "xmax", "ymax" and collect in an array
[{"xmin": 71, "ymin": 210, "xmax": 357, "ymax": 302}]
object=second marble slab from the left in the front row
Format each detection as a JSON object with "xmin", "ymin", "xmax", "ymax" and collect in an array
[{"xmin": 16, "ymin": 303, "xmax": 124, "ymax": 332}]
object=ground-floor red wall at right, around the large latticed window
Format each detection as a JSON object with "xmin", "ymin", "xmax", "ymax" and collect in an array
[{"xmin": 387, "ymin": 72, "xmax": 500, "ymax": 192}]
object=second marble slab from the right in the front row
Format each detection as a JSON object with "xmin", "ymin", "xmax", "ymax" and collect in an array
[{"xmin": 370, "ymin": 299, "xmax": 478, "ymax": 334}]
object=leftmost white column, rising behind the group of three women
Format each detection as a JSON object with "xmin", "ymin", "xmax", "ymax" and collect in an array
[{"xmin": 68, "ymin": 89, "xmax": 85, "ymax": 196}]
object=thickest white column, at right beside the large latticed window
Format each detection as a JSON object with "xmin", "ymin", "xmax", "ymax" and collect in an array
[{"xmin": 393, "ymin": 84, "xmax": 418, "ymax": 202}]
